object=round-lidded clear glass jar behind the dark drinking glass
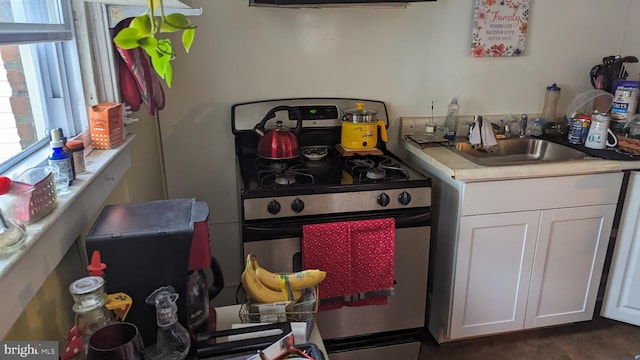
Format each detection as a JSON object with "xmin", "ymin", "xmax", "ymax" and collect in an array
[{"xmin": 69, "ymin": 276, "xmax": 116, "ymax": 355}]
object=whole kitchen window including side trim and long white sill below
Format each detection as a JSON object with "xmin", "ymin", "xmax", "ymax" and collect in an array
[{"xmin": 0, "ymin": 0, "xmax": 135, "ymax": 338}]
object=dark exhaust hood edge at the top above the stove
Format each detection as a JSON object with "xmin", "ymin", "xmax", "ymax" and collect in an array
[{"xmin": 249, "ymin": 0, "xmax": 436, "ymax": 8}]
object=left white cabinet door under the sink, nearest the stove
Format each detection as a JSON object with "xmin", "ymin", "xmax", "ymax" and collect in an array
[{"xmin": 450, "ymin": 211, "xmax": 540, "ymax": 339}]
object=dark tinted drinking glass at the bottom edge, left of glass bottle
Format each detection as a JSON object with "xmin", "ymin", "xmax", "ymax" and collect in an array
[{"xmin": 87, "ymin": 322, "xmax": 144, "ymax": 360}]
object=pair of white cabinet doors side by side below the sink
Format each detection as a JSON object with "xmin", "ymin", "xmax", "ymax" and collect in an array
[{"xmin": 451, "ymin": 205, "xmax": 615, "ymax": 339}]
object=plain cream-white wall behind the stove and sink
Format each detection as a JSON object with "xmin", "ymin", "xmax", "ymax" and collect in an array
[{"xmin": 155, "ymin": 0, "xmax": 640, "ymax": 300}]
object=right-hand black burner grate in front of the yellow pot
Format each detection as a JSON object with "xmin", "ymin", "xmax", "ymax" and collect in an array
[{"xmin": 344, "ymin": 156, "xmax": 409, "ymax": 182}]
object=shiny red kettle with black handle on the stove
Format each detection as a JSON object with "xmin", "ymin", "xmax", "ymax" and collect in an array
[{"xmin": 253, "ymin": 105, "xmax": 302, "ymax": 160}]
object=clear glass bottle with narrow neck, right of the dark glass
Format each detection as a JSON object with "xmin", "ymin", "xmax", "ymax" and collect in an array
[{"xmin": 145, "ymin": 287, "xmax": 191, "ymax": 360}]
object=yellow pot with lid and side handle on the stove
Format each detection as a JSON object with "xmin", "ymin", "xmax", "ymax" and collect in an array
[{"xmin": 340, "ymin": 103, "xmax": 387, "ymax": 150}]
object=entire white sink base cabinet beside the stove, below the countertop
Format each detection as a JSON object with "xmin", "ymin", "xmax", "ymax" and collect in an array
[{"xmin": 416, "ymin": 172, "xmax": 623, "ymax": 342}]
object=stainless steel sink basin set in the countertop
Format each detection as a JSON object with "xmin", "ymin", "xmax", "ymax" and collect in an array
[{"xmin": 451, "ymin": 138, "xmax": 591, "ymax": 166}]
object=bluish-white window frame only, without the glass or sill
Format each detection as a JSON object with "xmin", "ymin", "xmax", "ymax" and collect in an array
[{"xmin": 0, "ymin": 0, "xmax": 88, "ymax": 174}]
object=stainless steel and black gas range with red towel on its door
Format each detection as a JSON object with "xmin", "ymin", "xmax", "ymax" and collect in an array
[{"xmin": 232, "ymin": 98, "xmax": 431, "ymax": 360}]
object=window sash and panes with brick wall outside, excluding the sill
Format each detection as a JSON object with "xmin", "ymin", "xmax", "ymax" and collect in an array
[{"xmin": 0, "ymin": 0, "xmax": 88, "ymax": 173}]
